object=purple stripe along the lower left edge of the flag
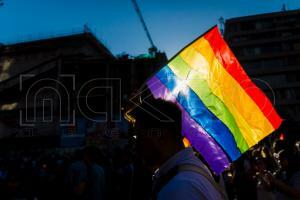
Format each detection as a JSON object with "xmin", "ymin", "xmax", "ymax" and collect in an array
[{"xmin": 147, "ymin": 76, "xmax": 230, "ymax": 174}]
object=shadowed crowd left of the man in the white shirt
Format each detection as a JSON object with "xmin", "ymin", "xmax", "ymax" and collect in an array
[{"xmin": 0, "ymin": 146, "xmax": 137, "ymax": 200}]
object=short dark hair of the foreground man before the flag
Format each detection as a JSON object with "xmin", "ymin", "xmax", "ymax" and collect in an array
[{"xmin": 135, "ymin": 99, "xmax": 182, "ymax": 139}]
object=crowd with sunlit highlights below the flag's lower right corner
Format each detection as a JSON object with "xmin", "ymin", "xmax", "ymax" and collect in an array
[{"xmin": 223, "ymin": 139, "xmax": 300, "ymax": 200}]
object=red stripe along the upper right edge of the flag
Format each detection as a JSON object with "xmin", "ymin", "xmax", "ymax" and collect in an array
[{"xmin": 204, "ymin": 26, "xmax": 282, "ymax": 129}]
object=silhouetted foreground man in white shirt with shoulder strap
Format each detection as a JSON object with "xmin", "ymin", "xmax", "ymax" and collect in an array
[{"xmin": 135, "ymin": 100, "xmax": 223, "ymax": 200}]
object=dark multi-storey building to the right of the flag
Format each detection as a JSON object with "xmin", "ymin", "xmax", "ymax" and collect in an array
[{"xmin": 224, "ymin": 10, "xmax": 300, "ymax": 141}]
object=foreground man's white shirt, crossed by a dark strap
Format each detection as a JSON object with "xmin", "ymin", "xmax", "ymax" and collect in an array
[{"xmin": 154, "ymin": 148, "xmax": 222, "ymax": 200}]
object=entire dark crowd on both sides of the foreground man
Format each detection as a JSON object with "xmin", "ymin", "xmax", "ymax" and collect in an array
[{"xmin": 0, "ymin": 140, "xmax": 300, "ymax": 200}]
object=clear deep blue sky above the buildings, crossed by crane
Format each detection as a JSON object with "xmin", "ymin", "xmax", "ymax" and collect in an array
[{"xmin": 0, "ymin": 0, "xmax": 300, "ymax": 57}]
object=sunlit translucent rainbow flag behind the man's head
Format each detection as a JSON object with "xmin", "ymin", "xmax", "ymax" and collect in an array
[{"xmin": 147, "ymin": 26, "xmax": 282, "ymax": 174}]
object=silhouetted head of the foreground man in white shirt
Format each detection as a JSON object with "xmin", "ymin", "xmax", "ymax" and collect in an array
[{"xmin": 135, "ymin": 99, "xmax": 184, "ymax": 170}]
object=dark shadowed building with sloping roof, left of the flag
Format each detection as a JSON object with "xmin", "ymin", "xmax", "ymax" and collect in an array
[{"xmin": 0, "ymin": 29, "xmax": 166, "ymax": 148}]
